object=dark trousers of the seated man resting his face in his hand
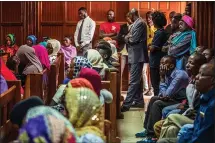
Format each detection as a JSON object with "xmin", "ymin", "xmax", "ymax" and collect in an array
[{"xmin": 144, "ymin": 96, "xmax": 179, "ymax": 136}]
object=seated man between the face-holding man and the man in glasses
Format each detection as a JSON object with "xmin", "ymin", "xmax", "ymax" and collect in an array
[{"xmin": 162, "ymin": 53, "xmax": 207, "ymax": 119}]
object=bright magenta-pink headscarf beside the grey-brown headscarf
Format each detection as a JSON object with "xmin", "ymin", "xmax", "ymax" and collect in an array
[{"xmin": 32, "ymin": 45, "xmax": 50, "ymax": 69}]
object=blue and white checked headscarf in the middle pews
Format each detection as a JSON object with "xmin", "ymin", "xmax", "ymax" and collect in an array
[{"xmin": 73, "ymin": 56, "xmax": 92, "ymax": 78}]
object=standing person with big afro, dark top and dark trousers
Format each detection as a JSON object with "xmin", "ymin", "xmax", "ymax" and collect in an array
[{"xmin": 148, "ymin": 11, "xmax": 168, "ymax": 96}]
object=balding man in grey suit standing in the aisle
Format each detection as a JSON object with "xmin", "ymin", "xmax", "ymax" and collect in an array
[{"xmin": 121, "ymin": 8, "xmax": 148, "ymax": 112}]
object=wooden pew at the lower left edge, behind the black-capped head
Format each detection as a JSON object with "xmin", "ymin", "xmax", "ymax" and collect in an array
[{"xmin": 0, "ymin": 84, "xmax": 21, "ymax": 143}]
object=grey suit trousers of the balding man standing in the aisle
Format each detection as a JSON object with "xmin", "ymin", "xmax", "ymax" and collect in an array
[{"xmin": 122, "ymin": 62, "xmax": 144, "ymax": 109}]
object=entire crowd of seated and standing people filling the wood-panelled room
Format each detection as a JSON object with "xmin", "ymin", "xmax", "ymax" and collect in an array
[{"xmin": 0, "ymin": 5, "xmax": 215, "ymax": 143}]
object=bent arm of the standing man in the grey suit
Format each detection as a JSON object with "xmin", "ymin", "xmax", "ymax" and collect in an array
[{"xmin": 128, "ymin": 22, "xmax": 147, "ymax": 44}]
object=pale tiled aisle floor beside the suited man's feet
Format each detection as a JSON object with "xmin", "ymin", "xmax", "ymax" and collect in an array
[{"xmin": 118, "ymin": 93, "xmax": 152, "ymax": 143}]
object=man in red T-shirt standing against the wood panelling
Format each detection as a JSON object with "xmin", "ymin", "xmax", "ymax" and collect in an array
[{"xmin": 99, "ymin": 9, "xmax": 120, "ymax": 47}]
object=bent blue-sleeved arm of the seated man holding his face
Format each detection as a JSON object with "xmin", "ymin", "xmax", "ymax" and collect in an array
[{"xmin": 160, "ymin": 71, "xmax": 188, "ymax": 97}]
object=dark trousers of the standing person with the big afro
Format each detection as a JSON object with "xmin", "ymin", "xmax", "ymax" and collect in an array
[{"xmin": 150, "ymin": 67, "xmax": 160, "ymax": 96}]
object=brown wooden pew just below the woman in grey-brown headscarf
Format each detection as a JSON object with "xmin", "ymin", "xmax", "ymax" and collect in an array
[{"xmin": 24, "ymin": 69, "xmax": 49, "ymax": 103}]
